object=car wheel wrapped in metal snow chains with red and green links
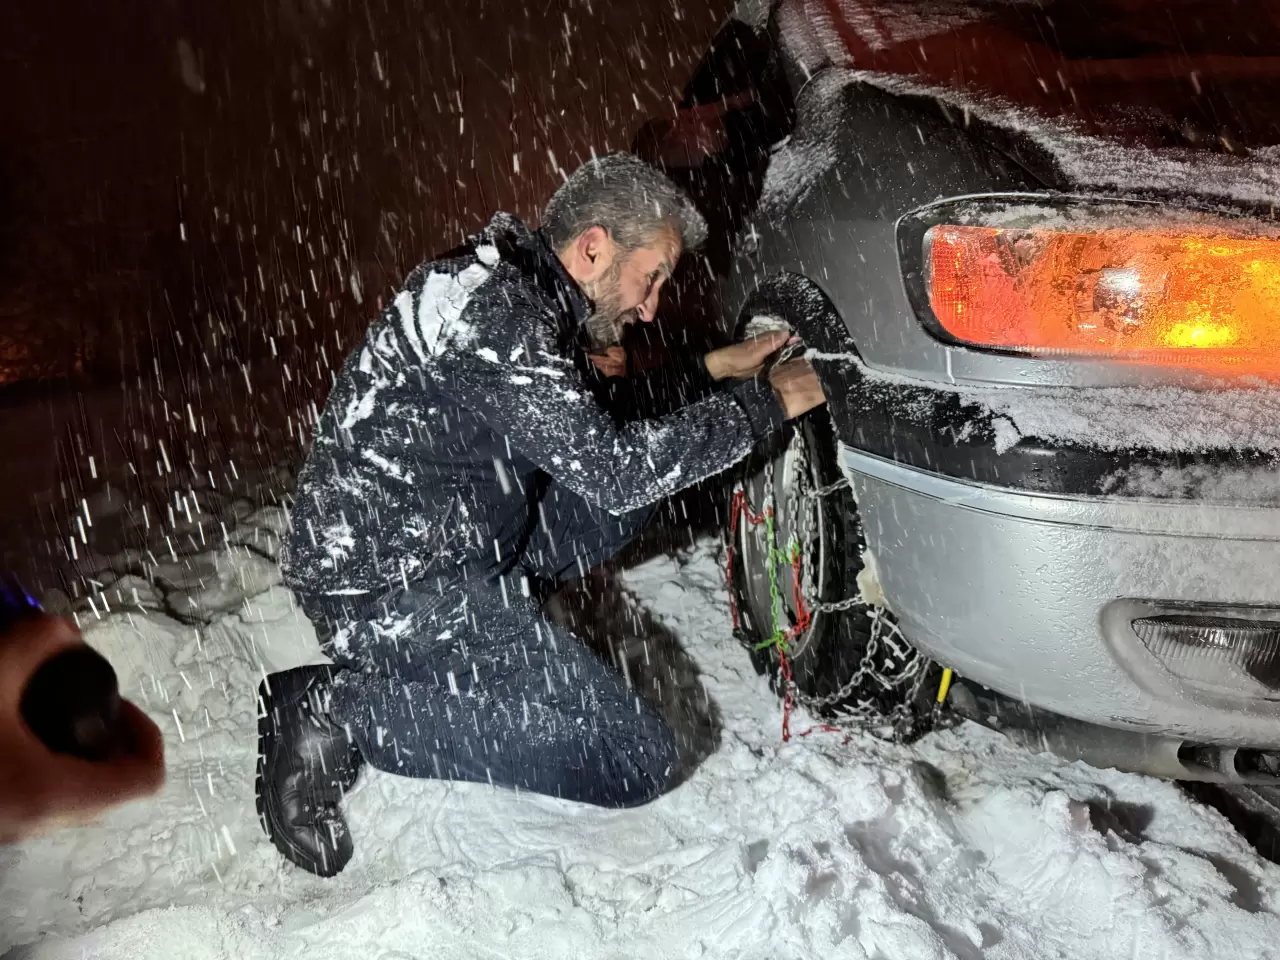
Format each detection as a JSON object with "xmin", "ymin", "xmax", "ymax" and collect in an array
[{"xmin": 727, "ymin": 389, "xmax": 931, "ymax": 739}]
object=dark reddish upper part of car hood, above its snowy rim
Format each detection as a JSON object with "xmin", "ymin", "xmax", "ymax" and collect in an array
[{"xmin": 780, "ymin": 0, "xmax": 1280, "ymax": 154}]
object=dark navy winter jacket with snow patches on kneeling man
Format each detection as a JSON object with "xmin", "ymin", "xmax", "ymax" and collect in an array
[{"xmin": 283, "ymin": 214, "xmax": 783, "ymax": 596}]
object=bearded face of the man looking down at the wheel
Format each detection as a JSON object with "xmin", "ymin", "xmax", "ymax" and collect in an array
[{"xmin": 584, "ymin": 229, "xmax": 681, "ymax": 348}]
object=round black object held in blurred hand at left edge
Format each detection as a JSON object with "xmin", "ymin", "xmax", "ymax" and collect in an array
[{"xmin": 0, "ymin": 576, "xmax": 129, "ymax": 760}]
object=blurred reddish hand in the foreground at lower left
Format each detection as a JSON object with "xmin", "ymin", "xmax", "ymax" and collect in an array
[{"xmin": 0, "ymin": 617, "xmax": 164, "ymax": 844}]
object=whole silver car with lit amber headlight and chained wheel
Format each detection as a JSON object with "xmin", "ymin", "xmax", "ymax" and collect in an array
[{"xmin": 649, "ymin": 0, "xmax": 1280, "ymax": 782}]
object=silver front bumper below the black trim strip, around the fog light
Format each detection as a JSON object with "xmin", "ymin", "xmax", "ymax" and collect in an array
[{"xmin": 840, "ymin": 444, "xmax": 1280, "ymax": 748}]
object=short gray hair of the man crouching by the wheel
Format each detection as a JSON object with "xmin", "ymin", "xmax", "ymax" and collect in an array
[{"xmin": 543, "ymin": 154, "xmax": 707, "ymax": 252}]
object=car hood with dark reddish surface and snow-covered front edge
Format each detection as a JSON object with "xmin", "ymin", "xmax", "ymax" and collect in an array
[{"xmin": 764, "ymin": 0, "xmax": 1280, "ymax": 207}]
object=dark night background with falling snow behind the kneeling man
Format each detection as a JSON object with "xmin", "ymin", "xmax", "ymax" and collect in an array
[{"xmin": 0, "ymin": 0, "xmax": 730, "ymax": 591}]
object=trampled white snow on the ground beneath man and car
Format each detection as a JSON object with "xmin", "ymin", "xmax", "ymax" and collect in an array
[{"xmin": 0, "ymin": 522, "xmax": 1280, "ymax": 960}]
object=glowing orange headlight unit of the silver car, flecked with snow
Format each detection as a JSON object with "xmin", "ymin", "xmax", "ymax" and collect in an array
[{"xmin": 918, "ymin": 202, "xmax": 1280, "ymax": 372}]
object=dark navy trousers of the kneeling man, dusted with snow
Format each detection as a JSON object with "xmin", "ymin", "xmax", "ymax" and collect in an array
[{"xmin": 302, "ymin": 484, "xmax": 677, "ymax": 806}]
